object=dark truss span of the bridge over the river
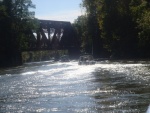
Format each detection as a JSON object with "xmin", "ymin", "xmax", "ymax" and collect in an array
[{"xmin": 28, "ymin": 20, "xmax": 77, "ymax": 50}]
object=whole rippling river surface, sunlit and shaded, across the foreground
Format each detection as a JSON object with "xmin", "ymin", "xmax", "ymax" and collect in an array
[{"xmin": 0, "ymin": 61, "xmax": 150, "ymax": 113}]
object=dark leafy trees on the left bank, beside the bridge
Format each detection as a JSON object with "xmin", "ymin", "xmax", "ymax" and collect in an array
[{"xmin": 0, "ymin": 0, "xmax": 35, "ymax": 65}]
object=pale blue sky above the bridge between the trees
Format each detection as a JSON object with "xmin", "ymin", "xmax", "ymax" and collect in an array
[{"xmin": 32, "ymin": 0, "xmax": 82, "ymax": 22}]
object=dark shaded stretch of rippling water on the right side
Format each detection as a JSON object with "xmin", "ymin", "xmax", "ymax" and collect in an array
[{"xmin": 93, "ymin": 61, "xmax": 150, "ymax": 113}]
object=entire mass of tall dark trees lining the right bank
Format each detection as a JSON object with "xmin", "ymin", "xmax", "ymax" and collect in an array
[{"xmin": 73, "ymin": 0, "xmax": 150, "ymax": 59}]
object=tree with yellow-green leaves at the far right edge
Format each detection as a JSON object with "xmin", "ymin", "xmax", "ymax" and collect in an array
[{"xmin": 130, "ymin": 0, "xmax": 150, "ymax": 57}]
